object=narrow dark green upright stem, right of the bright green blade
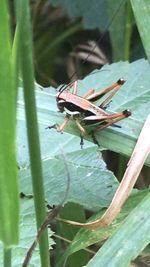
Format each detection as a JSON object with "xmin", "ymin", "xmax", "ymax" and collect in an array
[{"xmin": 20, "ymin": 0, "xmax": 50, "ymax": 267}]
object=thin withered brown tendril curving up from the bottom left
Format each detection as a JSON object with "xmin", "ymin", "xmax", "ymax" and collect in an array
[{"xmin": 22, "ymin": 148, "xmax": 71, "ymax": 267}]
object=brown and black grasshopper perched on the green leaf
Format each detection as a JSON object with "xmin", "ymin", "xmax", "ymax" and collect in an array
[{"xmin": 47, "ymin": 79, "xmax": 131, "ymax": 148}]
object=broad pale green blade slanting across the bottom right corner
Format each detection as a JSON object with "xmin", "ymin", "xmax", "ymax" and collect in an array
[{"xmin": 86, "ymin": 193, "xmax": 150, "ymax": 267}]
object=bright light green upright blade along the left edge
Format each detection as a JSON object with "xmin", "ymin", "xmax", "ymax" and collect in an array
[{"xmin": 0, "ymin": 0, "xmax": 19, "ymax": 247}]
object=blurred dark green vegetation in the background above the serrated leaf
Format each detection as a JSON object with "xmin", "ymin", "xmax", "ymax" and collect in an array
[{"xmin": 10, "ymin": 0, "xmax": 145, "ymax": 86}]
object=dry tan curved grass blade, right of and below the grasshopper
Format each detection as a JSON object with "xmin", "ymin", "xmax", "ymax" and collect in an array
[{"xmin": 59, "ymin": 114, "xmax": 150, "ymax": 230}]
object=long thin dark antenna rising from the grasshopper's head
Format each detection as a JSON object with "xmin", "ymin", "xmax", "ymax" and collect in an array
[{"xmin": 59, "ymin": 0, "xmax": 127, "ymax": 93}]
